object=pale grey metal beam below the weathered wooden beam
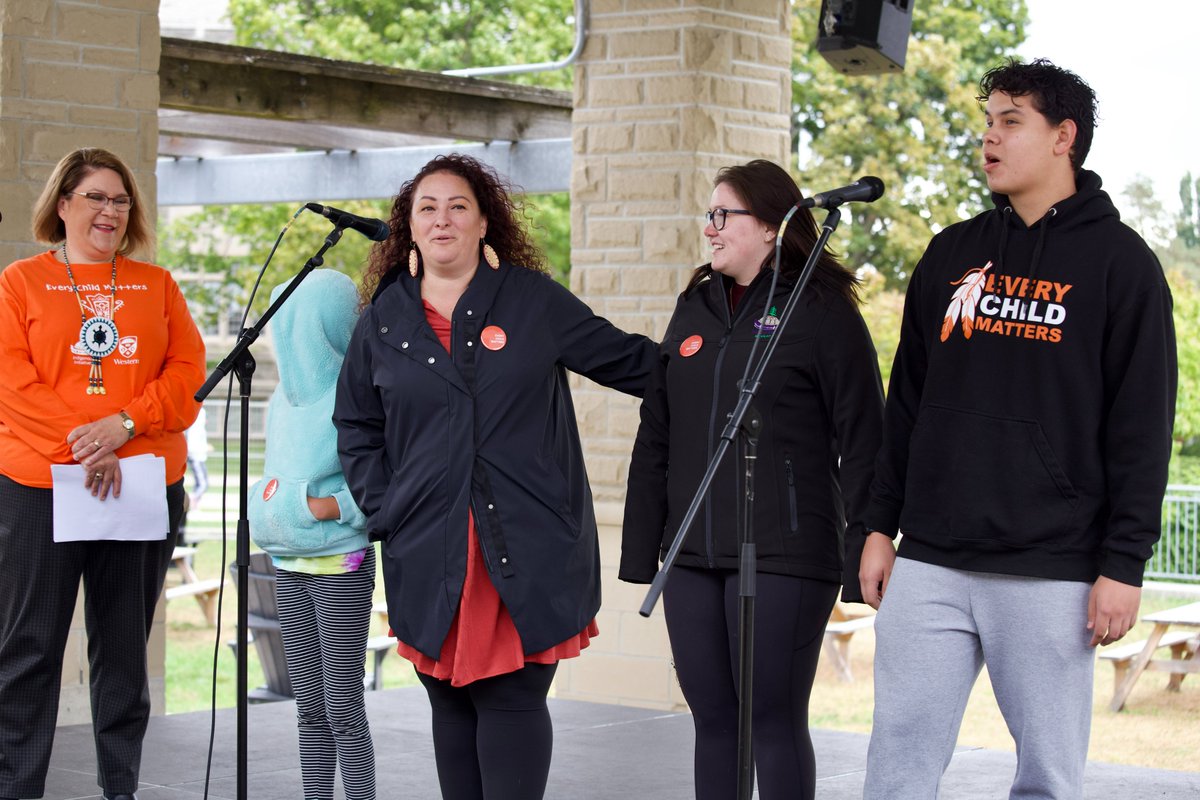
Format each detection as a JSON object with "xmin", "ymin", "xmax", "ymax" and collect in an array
[{"xmin": 157, "ymin": 138, "xmax": 571, "ymax": 206}]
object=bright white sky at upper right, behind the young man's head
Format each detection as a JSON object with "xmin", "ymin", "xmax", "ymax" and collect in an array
[{"xmin": 1019, "ymin": 0, "xmax": 1200, "ymax": 213}]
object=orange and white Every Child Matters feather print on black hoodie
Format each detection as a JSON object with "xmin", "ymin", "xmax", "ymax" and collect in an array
[{"xmin": 940, "ymin": 261, "xmax": 1073, "ymax": 343}]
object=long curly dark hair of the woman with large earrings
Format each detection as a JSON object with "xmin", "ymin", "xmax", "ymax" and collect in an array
[{"xmin": 362, "ymin": 152, "xmax": 547, "ymax": 301}]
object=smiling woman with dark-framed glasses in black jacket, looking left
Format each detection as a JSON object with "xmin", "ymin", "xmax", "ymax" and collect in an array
[{"xmin": 619, "ymin": 161, "xmax": 883, "ymax": 800}]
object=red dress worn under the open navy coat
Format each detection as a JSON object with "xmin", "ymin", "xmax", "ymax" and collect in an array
[{"xmin": 396, "ymin": 302, "xmax": 600, "ymax": 686}]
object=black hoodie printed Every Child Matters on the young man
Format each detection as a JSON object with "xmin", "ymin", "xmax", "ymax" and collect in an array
[{"xmin": 866, "ymin": 170, "xmax": 1176, "ymax": 585}]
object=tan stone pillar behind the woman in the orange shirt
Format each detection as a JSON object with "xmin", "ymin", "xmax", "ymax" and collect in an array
[{"xmin": 0, "ymin": 0, "xmax": 164, "ymax": 724}]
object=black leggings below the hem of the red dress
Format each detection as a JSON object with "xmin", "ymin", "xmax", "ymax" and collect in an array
[{"xmin": 416, "ymin": 663, "xmax": 558, "ymax": 800}]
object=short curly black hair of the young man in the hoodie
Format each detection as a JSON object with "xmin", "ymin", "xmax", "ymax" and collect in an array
[{"xmin": 976, "ymin": 59, "xmax": 1096, "ymax": 172}]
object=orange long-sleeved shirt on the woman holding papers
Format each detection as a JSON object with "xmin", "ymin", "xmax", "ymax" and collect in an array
[{"xmin": 0, "ymin": 251, "xmax": 205, "ymax": 488}]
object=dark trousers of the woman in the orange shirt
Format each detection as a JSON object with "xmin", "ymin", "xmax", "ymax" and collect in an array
[{"xmin": 0, "ymin": 476, "xmax": 184, "ymax": 798}]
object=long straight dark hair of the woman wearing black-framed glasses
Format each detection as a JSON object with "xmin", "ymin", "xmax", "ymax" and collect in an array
[{"xmin": 684, "ymin": 158, "xmax": 862, "ymax": 305}]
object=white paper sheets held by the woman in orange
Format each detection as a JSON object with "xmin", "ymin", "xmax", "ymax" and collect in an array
[{"xmin": 50, "ymin": 453, "xmax": 169, "ymax": 542}]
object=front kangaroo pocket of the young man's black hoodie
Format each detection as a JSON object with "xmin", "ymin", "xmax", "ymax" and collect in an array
[{"xmin": 900, "ymin": 405, "xmax": 1079, "ymax": 548}]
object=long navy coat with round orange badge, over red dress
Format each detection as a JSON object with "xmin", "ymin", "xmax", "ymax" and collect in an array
[{"xmin": 334, "ymin": 264, "xmax": 655, "ymax": 658}]
